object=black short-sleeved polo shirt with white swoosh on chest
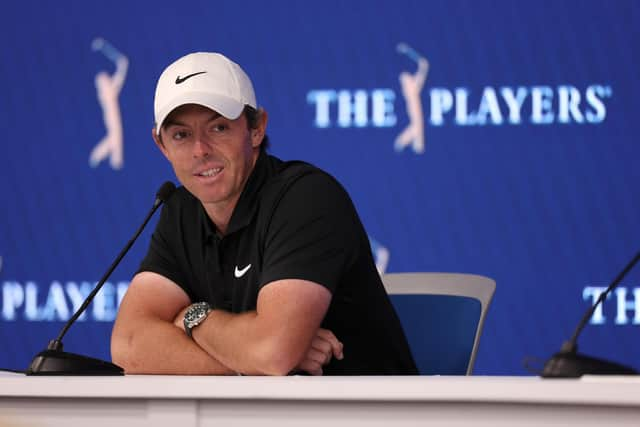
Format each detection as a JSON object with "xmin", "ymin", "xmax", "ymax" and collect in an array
[{"xmin": 139, "ymin": 152, "xmax": 417, "ymax": 375}]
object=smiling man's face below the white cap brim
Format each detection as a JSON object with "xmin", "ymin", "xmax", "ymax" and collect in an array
[{"xmin": 154, "ymin": 104, "xmax": 266, "ymax": 215}]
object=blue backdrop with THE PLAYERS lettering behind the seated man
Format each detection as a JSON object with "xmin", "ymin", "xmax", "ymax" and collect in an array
[{"xmin": 0, "ymin": 0, "xmax": 640, "ymax": 375}]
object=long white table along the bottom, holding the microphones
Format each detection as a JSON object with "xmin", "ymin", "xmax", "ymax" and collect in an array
[{"xmin": 0, "ymin": 373, "xmax": 640, "ymax": 427}]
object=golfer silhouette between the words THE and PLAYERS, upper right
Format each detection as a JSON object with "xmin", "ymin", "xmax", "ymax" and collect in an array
[{"xmin": 393, "ymin": 43, "xmax": 429, "ymax": 154}]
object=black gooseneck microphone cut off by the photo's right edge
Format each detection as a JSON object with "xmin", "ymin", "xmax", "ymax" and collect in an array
[{"xmin": 541, "ymin": 252, "xmax": 640, "ymax": 378}]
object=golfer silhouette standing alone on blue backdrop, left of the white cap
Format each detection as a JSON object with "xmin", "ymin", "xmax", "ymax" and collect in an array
[{"xmin": 89, "ymin": 38, "xmax": 129, "ymax": 169}]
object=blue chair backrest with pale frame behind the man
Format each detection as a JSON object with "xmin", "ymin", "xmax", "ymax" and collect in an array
[{"xmin": 382, "ymin": 273, "xmax": 496, "ymax": 375}]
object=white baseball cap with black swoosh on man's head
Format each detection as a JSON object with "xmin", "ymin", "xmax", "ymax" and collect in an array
[{"xmin": 153, "ymin": 52, "xmax": 258, "ymax": 134}]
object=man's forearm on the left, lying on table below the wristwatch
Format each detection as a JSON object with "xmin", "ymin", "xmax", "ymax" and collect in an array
[{"xmin": 111, "ymin": 318, "xmax": 235, "ymax": 375}]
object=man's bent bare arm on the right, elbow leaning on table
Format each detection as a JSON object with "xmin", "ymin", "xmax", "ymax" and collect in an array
[{"xmin": 193, "ymin": 279, "xmax": 342, "ymax": 375}]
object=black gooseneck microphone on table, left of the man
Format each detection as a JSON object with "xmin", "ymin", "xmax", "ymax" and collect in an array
[{"xmin": 25, "ymin": 181, "xmax": 176, "ymax": 375}]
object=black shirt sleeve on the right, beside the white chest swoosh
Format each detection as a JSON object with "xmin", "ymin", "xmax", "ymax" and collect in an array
[{"xmin": 260, "ymin": 171, "xmax": 360, "ymax": 293}]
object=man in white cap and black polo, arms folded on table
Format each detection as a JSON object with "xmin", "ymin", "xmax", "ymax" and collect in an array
[{"xmin": 111, "ymin": 53, "xmax": 416, "ymax": 375}]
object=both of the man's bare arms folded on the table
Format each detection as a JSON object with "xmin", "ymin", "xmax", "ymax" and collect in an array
[{"xmin": 111, "ymin": 272, "xmax": 342, "ymax": 375}]
